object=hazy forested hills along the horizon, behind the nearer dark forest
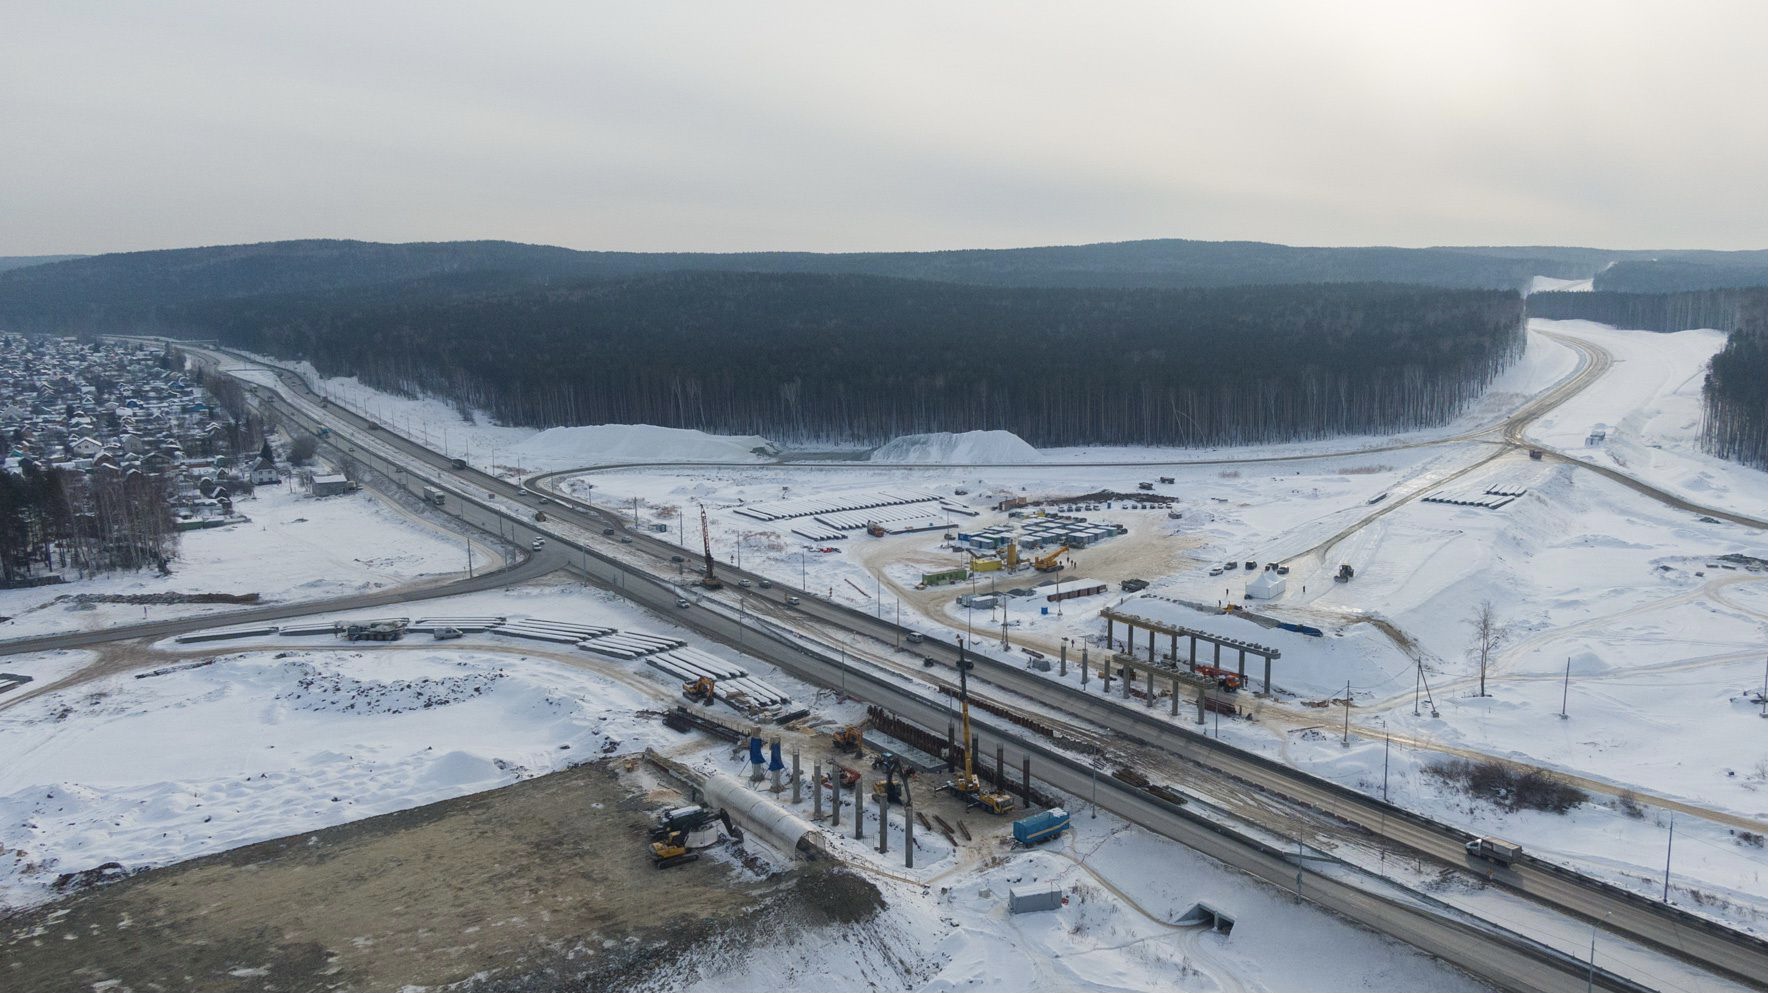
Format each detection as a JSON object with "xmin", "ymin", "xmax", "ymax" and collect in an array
[{"xmin": 13, "ymin": 239, "xmax": 1768, "ymax": 334}]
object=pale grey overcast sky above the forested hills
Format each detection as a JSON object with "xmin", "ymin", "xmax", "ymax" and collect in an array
[{"xmin": 0, "ymin": 0, "xmax": 1768, "ymax": 254}]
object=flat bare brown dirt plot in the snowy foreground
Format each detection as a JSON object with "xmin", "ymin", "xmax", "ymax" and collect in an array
[{"xmin": 0, "ymin": 760, "xmax": 880, "ymax": 993}]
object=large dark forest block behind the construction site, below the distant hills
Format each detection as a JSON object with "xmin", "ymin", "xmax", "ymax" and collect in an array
[{"xmin": 177, "ymin": 272, "xmax": 1522, "ymax": 445}]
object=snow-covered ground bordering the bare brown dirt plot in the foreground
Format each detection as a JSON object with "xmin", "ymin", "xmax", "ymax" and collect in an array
[{"xmin": 0, "ymin": 583, "xmax": 1478, "ymax": 991}]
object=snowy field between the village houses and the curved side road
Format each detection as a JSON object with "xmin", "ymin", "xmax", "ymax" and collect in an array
[{"xmin": 0, "ymin": 484, "xmax": 495, "ymax": 640}]
